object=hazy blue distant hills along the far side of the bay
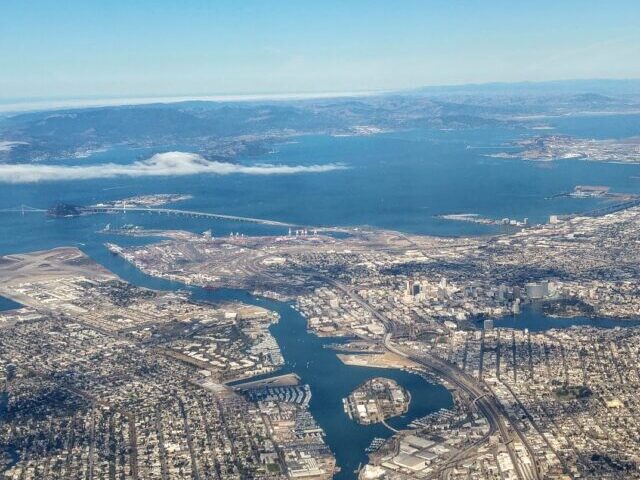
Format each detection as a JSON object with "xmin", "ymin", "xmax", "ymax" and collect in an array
[{"xmin": 0, "ymin": 80, "xmax": 640, "ymax": 163}]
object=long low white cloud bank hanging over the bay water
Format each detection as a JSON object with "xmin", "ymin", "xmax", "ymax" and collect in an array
[{"xmin": 0, "ymin": 152, "xmax": 347, "ymax": 183}]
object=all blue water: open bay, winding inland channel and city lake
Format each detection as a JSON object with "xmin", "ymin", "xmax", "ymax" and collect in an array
[{"xmin": 0, "ymin": 116, "xmax": 640, "ymax": 478}]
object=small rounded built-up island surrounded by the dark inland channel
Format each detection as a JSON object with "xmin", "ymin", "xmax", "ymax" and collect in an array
[{"xmin": 343, "ymin": 377, "xmax": 411, "ymax": 425}]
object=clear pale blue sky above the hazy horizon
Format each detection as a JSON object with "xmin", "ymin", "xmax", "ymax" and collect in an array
[{"xmin": 0, "ymin": 0, "xmax": 640, "ymax": 100}]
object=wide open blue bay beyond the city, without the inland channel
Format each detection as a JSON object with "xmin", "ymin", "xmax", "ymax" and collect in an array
[{"xmin": 0, "ymin": 115, "xmax": 640, "ymax": 252}]
